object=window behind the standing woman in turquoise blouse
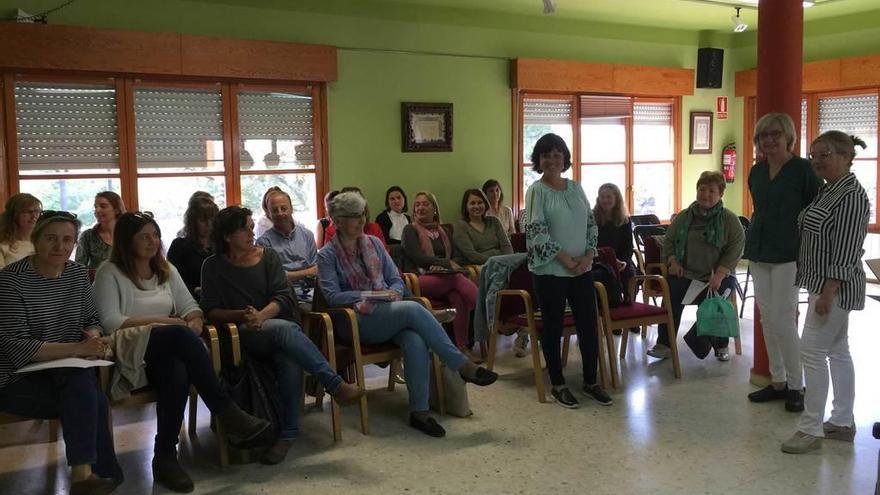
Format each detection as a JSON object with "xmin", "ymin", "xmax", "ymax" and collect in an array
[{"xmin": 520, "ymin": 95, "xmax": 679, "ymax": 219}]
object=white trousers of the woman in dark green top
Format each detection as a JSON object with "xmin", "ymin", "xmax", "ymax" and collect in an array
[{"xmin": 749, "ymin": 261, "xmax": 804, "ymax": 390}]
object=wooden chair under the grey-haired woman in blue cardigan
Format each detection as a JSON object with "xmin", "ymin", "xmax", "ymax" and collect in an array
[{"xmin": 315, "ymin": 286, "xmax": 446, "ymax": 435}]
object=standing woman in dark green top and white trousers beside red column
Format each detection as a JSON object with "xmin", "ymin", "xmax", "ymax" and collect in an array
[{"xmin": 743, "ymin": 113, "xmax": 822, "ymax": 412}]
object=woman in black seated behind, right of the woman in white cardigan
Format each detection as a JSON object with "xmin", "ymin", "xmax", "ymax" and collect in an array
[{"xmin": 168, "ymin": 198, "xmax": 219, "ymax": 301}]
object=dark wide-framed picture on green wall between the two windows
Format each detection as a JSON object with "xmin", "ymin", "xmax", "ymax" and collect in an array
[{"xmin": 400, "ymin": 102, "xmax": 452, "ymax": 152}]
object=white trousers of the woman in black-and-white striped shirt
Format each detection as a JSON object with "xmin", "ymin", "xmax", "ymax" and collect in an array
[{"xmin": 798, "ymin": 294, "xmax": 856, "ymax": 437}]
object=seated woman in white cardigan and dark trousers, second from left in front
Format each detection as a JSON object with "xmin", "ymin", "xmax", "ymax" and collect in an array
[{"xmin": 95, "ymin": 213, "xmax": 269, "ymax": 492}]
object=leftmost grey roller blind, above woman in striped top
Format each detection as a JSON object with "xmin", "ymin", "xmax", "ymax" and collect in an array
[{"xmin": 15, "ymin": 82, "xmax": 119, "ymax": 173}]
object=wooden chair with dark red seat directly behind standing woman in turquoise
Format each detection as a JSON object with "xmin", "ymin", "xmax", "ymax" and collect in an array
[{"xmin": 486, "ymin": 265, "xmax": 608, "ymax": 402}]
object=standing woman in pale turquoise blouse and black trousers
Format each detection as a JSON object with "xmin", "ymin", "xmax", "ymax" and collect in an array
[{"xmin": 523, "ymin": 134, "xmax": 614, "ymax": 409}]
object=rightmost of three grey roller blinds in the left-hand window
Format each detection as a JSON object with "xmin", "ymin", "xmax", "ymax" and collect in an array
[{"xmin": 238, "ymin": 92, "xmax": 315, "ymax": 168}]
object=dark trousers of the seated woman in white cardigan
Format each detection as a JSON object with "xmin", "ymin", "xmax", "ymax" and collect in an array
[{"xmin": 144, "ymin": 325, "xmax": 230, "ymax": 455}]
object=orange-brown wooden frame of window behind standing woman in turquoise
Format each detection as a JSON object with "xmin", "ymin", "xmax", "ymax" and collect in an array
[{"xmin": 511, "ymin": 89, "xmax": 682, "ymax": 219}]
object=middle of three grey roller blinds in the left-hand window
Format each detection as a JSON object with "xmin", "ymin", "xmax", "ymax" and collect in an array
[{"xmin": 134, "ymin": 88, "xmax": 223, "ymax": 168}]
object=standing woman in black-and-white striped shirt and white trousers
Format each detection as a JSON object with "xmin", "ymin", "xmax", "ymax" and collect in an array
[{"xmin": 782, "ymin": 131, "xmax": 871, "ymax": 454}]
